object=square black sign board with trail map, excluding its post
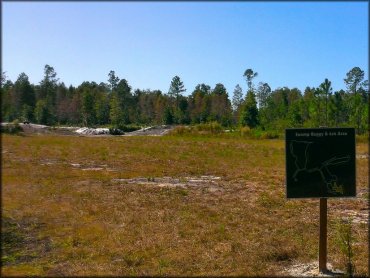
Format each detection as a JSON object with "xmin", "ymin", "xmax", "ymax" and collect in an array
[{"xmin": 285, "ymin": 128, "xmax": 356, "ymax": 198}]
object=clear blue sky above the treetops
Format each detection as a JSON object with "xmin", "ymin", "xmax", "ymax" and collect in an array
[{"xmin": 1, "ymin": 2, "xmax": 369, "ymax": 96}]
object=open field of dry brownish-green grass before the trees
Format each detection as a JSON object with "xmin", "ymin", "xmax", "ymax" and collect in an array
[{"xmin": 1, "ymin": 135, "xmax": 369, "ymax": 276}]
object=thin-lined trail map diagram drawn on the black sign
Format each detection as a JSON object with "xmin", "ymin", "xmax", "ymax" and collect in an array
[{"xmin": 289, "ymin": 140, "xmax": 350, "ymax": 195}]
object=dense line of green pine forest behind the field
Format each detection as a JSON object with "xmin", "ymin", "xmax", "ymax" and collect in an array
[{"xmin": 1, "ymin": 65, "xmax": 369, "ymax": 134}]
